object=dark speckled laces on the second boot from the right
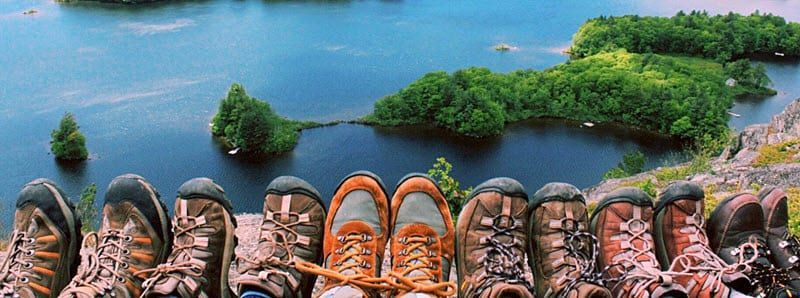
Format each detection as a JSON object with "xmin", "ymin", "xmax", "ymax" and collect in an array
[{"xmin": 730, "ymin": 235, "xmax": 791, "ymax": 297}]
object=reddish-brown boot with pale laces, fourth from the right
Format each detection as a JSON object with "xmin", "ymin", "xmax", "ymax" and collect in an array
[{"xmin": 591, "ymin": 187, "xmax": 687, "ymax": 298}]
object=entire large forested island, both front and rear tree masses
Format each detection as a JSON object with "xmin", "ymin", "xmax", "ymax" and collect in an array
[{"xmin": 363, "ymin": 12, "xmax": 788, "ymax": 140}]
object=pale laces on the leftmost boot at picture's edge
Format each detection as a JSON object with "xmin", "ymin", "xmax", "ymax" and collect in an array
[{"xmin": 0, "ymin": 232, "xmax": 36, "ymax": 295}]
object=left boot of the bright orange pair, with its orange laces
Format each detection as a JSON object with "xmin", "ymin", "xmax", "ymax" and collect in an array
[{"xmin": 297, "ymin": 171, "xmax": 392, "ymax": 297}]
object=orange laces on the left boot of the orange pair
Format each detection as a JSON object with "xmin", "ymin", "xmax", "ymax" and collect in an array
[{"xmin": 295, "ymin": 233, "xmax": 393, "ymax": 291}]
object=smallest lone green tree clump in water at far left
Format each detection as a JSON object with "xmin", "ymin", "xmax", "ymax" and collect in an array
[{"xmin": 50, "ymin": 113, "xmax": 89, "ymax": 160}]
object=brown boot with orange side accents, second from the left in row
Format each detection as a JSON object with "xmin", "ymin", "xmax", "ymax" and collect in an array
[{"xmin": 59, "ymin": 174, "xmax": 172, "ymax": 298}]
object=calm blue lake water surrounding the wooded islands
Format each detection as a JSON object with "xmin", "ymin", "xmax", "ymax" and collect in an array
[{"xmin": 0, "ymin": 0, "xmax": 800, "ymax": 214}]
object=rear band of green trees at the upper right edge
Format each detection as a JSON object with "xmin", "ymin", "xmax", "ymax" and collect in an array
[{"xmin": 570, "ymin": 11, "xmax": 800, "ymax": 61}]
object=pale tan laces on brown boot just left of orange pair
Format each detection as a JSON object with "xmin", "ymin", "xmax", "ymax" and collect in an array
[{"xmin": 239, "ymin": 207, "xmax": 311, "ymax": 288}]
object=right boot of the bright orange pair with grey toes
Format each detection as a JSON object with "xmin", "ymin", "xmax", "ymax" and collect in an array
[{"xmin": 389, "ymin": 174, "xmax": 456, "ymax": 297}]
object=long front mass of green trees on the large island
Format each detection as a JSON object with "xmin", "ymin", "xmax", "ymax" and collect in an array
[{"xmin": 364, "ymin": 50, "xmax": 734, "ymax": 139}]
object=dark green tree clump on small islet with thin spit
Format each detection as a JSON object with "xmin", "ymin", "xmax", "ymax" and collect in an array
[{"xmin": 211, "ymin": 83, "xmax": 318, "ymax": 153}]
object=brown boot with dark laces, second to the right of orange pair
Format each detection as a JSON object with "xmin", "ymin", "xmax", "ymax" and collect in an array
[{"xmin": 528, "ymin": 183, "xmax": 611, "ymax": 298}]
